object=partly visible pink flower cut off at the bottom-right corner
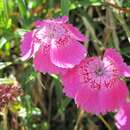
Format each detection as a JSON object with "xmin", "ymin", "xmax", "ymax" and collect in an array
[{"xmin": 115, "ymin": 102, "xmax": 130, "ymax": 130}]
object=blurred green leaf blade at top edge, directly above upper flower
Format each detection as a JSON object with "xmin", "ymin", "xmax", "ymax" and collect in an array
[{"xmin": 61, "ymin": 0, "xmax": 70, "ymax": 15}]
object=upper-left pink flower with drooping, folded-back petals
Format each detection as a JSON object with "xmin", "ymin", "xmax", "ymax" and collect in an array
[{"xmin": 21, "ymin": 16, "xmax": 86, "ymax": 73}]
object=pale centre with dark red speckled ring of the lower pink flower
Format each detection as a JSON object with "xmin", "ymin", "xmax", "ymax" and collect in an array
[{"xmin": 79, "ymin": 57, "xmax": 119, "ymax": 90}]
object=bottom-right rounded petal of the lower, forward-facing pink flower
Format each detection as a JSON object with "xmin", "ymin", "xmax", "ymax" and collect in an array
[{"xmin": 100, "ymin": 80, "xmax": 128, "ymax": 111}]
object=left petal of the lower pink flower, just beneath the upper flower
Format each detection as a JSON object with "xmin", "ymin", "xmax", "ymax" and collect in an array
[{"xmin": 61, "ymin": 67, "xmax": 81, "ymax": 98}]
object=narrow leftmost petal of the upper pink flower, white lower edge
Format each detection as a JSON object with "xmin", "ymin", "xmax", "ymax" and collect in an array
[{"xmin": 20, "ymin": 32, "xmax": 34, "ymax": 60}]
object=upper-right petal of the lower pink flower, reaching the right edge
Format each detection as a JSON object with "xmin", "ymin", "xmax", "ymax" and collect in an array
[{"xmin": 104, "ymin": 48, "xmax": 130, "ymax": 77}]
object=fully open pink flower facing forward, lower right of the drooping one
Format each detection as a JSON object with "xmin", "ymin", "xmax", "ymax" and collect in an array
[{"xmin": 61, "ymin": 49, "xmax": 129, "ymax": 114}]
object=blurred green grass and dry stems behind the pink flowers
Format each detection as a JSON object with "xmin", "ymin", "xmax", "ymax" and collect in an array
[{"xmin": 0, "ymin": 0, "xmax": 130, "ymax": 130}]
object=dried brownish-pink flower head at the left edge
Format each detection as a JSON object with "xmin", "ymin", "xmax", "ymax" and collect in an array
[{"xmin": 0, "ymin": 84, "xmax": 22, "ymax": 110}]
